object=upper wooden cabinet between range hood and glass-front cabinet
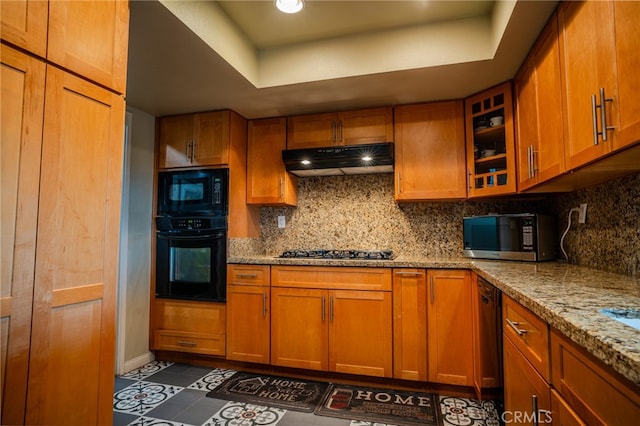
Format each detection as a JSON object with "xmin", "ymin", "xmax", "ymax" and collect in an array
[{"xmin": 394, "ymin": 101, "xmax": 467, "ymax": 201}]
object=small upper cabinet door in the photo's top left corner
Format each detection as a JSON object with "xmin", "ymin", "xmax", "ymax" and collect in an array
[{"xmin": 0, "ymin": 0, "xmax": 49, "ymax": 58}]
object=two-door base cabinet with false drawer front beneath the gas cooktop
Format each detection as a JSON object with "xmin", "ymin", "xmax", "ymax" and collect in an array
[{"xmin": 271, "ymin": 266, "xmax": 392, "ymax": 377}]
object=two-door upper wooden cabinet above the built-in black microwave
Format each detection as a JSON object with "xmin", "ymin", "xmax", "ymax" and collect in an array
[{"xmin": 158, "ymin": 110, "xmax": 235, "ymax": 169}]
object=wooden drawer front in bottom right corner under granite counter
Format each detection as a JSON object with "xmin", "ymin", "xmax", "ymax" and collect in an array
[{"xmin": 551, "ymin": 330, "xmax": 640, "ymax": 425}]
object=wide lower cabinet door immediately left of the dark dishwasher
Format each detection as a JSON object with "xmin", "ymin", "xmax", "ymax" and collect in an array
[{"xmin": 427, "ymin": 269, "xmax": 473, "ymax": 386}]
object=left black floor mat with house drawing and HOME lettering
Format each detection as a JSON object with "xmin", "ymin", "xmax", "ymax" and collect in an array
[{"xmin": 207, "ymin": 372, "xmax": 329, "ymax": 413}]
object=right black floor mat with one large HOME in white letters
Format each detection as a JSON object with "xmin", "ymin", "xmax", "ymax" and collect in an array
[{"xmin": 314, "ymin": 384, "xmax": 440, "ymax": 426}]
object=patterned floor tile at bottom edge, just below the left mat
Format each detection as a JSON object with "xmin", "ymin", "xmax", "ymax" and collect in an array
[{"xmin": 203, "ymin": 401, "xmax": 287, "ymax": 426}]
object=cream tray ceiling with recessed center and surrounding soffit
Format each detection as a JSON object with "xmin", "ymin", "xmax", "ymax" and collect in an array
[{"xmin": 127, "ymin": 0, "xmax": 557, "ymax": 118}]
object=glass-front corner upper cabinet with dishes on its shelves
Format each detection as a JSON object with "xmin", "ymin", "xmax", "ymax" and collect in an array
[{"xmin": 465, "ymin": 82, "xmax": 516, "ymax": 198}]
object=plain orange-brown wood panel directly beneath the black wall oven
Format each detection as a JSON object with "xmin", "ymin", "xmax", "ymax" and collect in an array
[{"xmin": 154, "ymin": 299, "xmax": 226, "ymax": 334}]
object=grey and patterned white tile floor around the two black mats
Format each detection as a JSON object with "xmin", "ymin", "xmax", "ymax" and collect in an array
[{"xmin": 113, "ymin": 361, "xmax": 500, "ymax": 426}]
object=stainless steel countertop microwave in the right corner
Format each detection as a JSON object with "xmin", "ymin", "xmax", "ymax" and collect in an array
[{"xmin": 462, "ymin": 213, "xmax": 558, "ymax": 262}]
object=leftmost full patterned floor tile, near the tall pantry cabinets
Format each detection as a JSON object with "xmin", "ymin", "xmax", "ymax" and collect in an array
[{"xmin": 113, "ymin": 381, "xmax": 183, "ymax": 415}]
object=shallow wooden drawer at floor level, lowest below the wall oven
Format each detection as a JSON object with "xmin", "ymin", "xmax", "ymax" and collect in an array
[{"xmin": 155, "ymin": 330, "xmax": 225, "ymax": 356}]
